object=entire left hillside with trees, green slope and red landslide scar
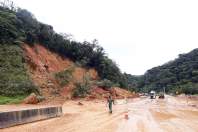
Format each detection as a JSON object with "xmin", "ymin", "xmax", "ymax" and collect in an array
[{"xmin": 0, "ymin": 2, "xmax": 135, "ymax": 100}]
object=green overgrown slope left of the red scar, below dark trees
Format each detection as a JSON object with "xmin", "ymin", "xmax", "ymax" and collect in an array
[{"xmin": 0, "ymin": 44, "xmax": 37, "ymax": 96}]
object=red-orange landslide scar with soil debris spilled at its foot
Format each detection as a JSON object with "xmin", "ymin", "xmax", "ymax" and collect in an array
[{"xmin": 22, "ymin": 44, "xmax": 135, "ymax": 101}]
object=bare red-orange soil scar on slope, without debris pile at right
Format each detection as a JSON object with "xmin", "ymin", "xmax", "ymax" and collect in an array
[{"xmin": 23, "ymin": 44, "xmax": 98, "ymax": 102}]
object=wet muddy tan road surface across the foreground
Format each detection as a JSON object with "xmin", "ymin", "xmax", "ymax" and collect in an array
[{"xmin": 0, "ymin": 95, "xmax": 198, "ymax": 132}]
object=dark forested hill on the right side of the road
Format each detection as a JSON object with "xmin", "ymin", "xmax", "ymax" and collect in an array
[{"xmin": 127, "ymin": 49, "xmax": 198, "ymax": 94}]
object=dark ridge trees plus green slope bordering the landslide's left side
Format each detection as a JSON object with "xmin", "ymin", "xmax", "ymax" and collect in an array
[{"xmin": 0, "ymin": 1, "xmax": 127, "ymax": 95}]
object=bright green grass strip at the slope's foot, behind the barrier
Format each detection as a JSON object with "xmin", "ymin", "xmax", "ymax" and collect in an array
[{"xmin": 0, "ymin": 95, "xmax": 26, "ymax": 105}]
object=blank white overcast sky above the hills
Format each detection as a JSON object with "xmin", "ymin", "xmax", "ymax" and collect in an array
[{"xmin": 14, "ymin": 0, "xmax": 198, "ymax": 75}]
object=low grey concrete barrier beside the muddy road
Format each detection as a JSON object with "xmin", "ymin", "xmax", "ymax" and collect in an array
[{"xmin": 0, "ymin": 106, "xmax": 62, "ymax": 128}]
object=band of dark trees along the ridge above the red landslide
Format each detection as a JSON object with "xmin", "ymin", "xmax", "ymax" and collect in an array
[{"xmin": 0, "ymin": 3, "xmax": 126, "ymax": 87}]
